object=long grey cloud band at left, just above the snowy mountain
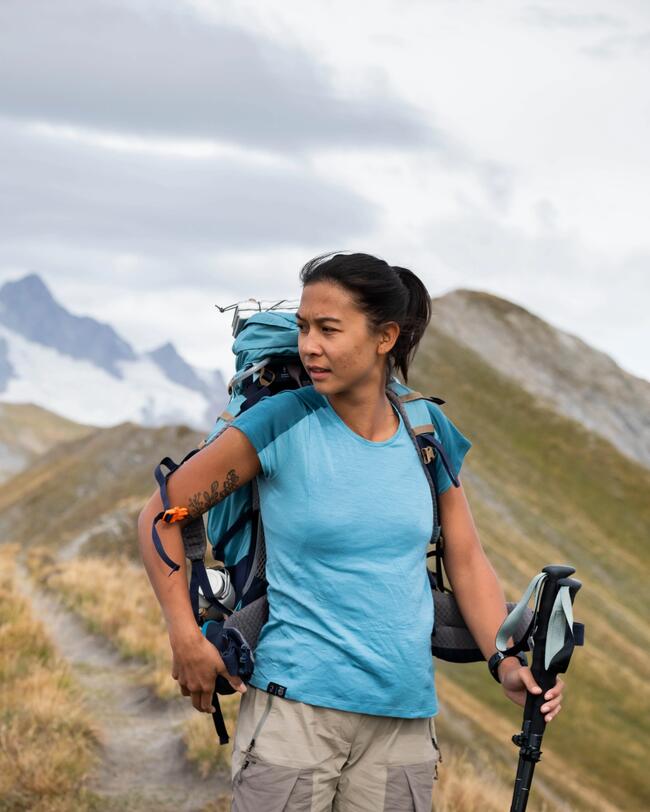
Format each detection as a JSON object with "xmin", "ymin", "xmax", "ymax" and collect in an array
[{"xmin": 0, "ymin": 125, "xmax": 378, "ymax": 263}]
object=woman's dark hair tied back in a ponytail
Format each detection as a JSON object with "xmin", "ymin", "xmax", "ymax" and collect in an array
[{"xmin": 300, "ymin": 252, "xmax": 431, "ymax": 383}]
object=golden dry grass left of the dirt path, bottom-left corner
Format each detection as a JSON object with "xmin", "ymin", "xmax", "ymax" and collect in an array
[{"xmin": 0, "ymin": 546, "xmax": 98, "ymax": 812}]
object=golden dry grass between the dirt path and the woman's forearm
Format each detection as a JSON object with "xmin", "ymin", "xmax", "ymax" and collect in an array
[{"xmin": 29, "ymin": 548, "xmax": 178, "ymax": 699}]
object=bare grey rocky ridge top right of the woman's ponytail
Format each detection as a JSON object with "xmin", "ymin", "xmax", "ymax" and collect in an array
[{"xmin": 432, "ymin": 290, "xmax": 650, "ymax": 467}]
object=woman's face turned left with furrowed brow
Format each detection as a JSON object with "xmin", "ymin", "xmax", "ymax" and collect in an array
[{"xmin": 296, "ymin": 282, "xmax": 399, "ymax": 395}]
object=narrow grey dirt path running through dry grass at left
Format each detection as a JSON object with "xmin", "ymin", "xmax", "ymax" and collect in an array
[{"xmin": 18, "ymin": 567, "xmax": 229, "ymax": 812}]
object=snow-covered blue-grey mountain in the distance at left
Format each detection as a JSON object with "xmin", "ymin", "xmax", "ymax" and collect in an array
[{"xmin": 0, "ymin": 274, "xmax": 228, "ymax": 431}]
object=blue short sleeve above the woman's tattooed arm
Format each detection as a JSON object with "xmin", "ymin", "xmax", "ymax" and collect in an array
[{"xmin": 230, "ymin": 390, "xmax": 301, "ymax": 479}]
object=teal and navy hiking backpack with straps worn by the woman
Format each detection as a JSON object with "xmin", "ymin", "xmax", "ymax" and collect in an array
[{"xmin": 152, "ymin": 306, "xmax": 530, "ymax": 744}]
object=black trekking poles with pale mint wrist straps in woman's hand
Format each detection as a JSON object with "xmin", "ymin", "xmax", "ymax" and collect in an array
[{"xmin": 497, "ymin": 565, "xmax": 584, "ymax": 812}]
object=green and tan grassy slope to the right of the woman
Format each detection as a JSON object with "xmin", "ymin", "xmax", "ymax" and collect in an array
[{"xmin": 409, "ymin": 328, "xmax": 650, "ymax": 810}]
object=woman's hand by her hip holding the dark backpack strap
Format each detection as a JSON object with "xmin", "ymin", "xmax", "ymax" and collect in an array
[{"xmin": 171, "ymin": 633, "xmax": 246, "ymax": 713}]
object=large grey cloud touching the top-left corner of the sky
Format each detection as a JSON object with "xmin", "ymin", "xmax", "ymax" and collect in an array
[{"xmin": 0, "ymin": 0, "xmax": 438, "ymax": 152}]
